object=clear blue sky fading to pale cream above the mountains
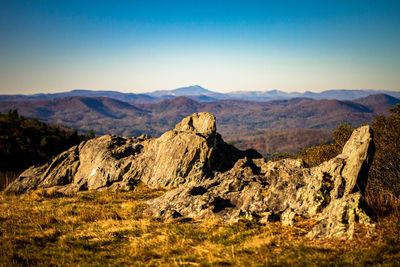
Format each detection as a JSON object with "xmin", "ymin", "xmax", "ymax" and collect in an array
[{"xmin": 0, "ymin": 0, "xmax": 400, "ymax": 94}]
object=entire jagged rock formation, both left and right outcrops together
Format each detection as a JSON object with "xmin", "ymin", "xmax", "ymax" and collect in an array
[{"xmin": 6, "ymin": 113, "xmax": 373, "ymax": 238}]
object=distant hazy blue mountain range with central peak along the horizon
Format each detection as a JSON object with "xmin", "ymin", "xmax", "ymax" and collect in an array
[{"xmin": 0, "ymin": 85, "xmax": 400, "ymax": 103}]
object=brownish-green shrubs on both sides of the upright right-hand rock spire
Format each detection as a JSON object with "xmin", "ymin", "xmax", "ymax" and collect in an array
[{"xmin": 299, "ymin": 104, "xmax": 400, "ymax": 219}]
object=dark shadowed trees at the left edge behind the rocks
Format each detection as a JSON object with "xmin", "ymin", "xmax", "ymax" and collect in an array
[{"xmin": 0, "ymin": 110, "xmax": 94, "ymax": 190}]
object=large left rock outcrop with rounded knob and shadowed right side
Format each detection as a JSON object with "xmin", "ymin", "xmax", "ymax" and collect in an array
[{"xmin": 5, "ymin": 112, "xmax": 261, "ymax": 193}]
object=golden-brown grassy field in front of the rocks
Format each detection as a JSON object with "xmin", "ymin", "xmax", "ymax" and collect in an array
[{"xmin": 0, "ymin": 186, "xmax": 400, "ymax": 266}]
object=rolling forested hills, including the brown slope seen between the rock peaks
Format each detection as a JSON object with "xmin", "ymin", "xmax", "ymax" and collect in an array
[{"xmin": 0, "ymin": 91, "xmax": 400, "ymax": 155}]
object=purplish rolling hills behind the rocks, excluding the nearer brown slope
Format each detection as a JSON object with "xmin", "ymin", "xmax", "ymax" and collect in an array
[{"xmin": 0, "ymin": 96, "xmax": 400, "ymax": 135}]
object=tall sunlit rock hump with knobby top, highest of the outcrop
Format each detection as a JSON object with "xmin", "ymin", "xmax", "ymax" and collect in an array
[{"xmin": 129, "ymin": 113, "xmax": 218, "ymax": 187}]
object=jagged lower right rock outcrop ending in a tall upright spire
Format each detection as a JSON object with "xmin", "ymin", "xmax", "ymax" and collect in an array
[{"xmin": 147, "ymin": 126, "xmax": 373, "ymax": 238}]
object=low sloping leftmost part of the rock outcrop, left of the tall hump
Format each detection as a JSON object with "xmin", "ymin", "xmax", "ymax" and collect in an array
[{"xmin": 5, "ymin": 135, "xmax": 150, "ymax": 193}]
